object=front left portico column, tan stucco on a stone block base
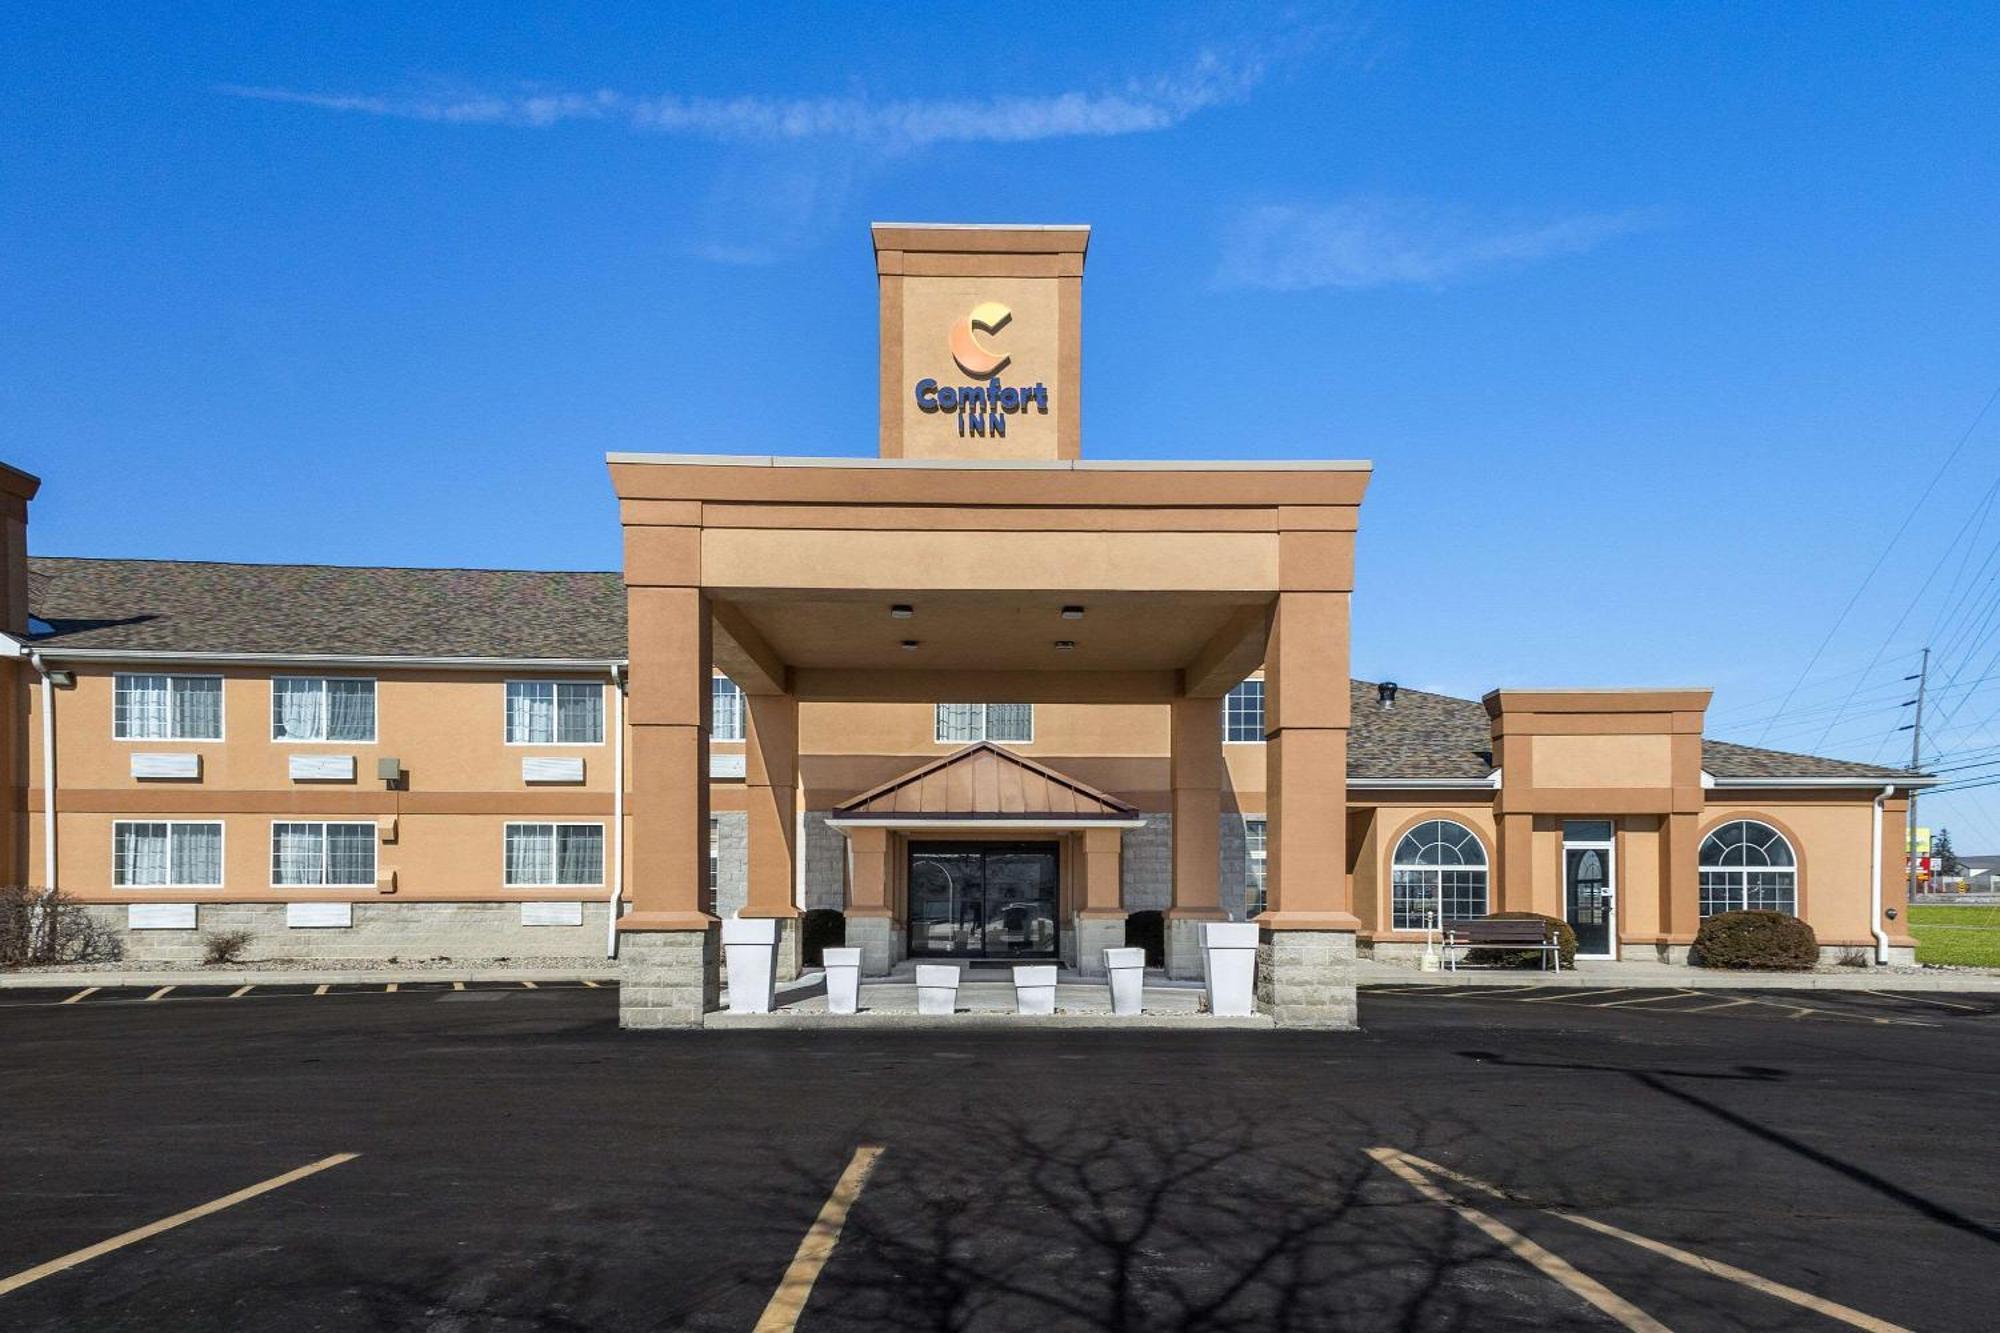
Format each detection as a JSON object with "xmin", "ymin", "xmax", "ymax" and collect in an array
[{"xmin": 618, "ymin": 580, "xmax": 720, "ymax": 1027}]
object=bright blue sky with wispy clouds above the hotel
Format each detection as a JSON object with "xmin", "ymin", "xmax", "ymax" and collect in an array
[{"xmin": 11, "ymin": 2, "xmax": 2000, "ymax": 851}]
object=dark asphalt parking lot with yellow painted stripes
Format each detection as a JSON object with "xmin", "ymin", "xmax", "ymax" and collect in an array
[{"xmin": 0, "ymin": 983, "xmax": 2000, "ymax": 1331}]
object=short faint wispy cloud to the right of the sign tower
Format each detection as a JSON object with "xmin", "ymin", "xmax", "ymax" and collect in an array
[{"xmin": 1216, "ymin": 198, "xmax": 1664, "ymax": 292}]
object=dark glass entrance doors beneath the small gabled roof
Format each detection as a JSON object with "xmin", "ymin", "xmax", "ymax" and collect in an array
[{"xmin": 910, "ymin": 843, "xmax": 1058, "ymax": 959}]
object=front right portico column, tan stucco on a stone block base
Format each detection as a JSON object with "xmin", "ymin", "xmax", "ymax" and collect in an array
[{"xmin": 1256, "ymin": 584, "xmax": 1360, "ymax": 1027}]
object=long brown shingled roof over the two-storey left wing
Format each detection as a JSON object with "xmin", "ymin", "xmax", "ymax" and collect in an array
[{"xmin": 28, "ymin": 556, "xmax": 626, "ymax": 660}]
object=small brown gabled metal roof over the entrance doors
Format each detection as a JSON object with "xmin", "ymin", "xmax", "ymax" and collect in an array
[{"xmin": 832, "ymin": 741, "xmax": 1138, "ymax": 823}]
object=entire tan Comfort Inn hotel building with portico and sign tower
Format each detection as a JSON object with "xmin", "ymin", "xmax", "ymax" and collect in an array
[{"xmin": 0, "ymin": 224, "xmax": 1922, "ymax": 1027}]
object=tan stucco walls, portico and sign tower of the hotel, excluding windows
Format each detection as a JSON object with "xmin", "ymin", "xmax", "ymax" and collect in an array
[{"xmin": 0, "ymin": 224, "xmax": 1912, "ymax": 1025}]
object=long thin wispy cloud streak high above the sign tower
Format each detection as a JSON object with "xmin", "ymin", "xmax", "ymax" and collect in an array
[{"xmin": 218, "ymin": 52, "xmax": 1266, "ymax": 148}]
